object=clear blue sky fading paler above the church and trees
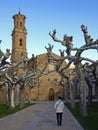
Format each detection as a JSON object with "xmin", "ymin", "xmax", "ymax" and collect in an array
[{"xmin": 0, "ymin": 0, "xmax": 98, "ymax": 60}]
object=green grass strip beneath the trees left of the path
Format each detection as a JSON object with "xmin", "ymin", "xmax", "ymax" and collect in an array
[{"xmin": 0, "ymin": 103, "xmax": 33, "ymax": 118}]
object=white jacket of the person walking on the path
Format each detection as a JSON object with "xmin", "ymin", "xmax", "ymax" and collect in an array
[{"xmin": 54, "ymin": 99, "xmax": 64, "ymax": 113}]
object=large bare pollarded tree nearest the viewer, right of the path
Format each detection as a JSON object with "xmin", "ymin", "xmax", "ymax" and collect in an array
[{"xmin": 47, "ymin": 25, "xmax": 98, "ymax": 116}]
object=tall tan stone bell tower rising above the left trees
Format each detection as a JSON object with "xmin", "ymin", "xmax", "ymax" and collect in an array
[{"xmin": 11, "ymin": 12, "xmax": 27, "ymax": 63}]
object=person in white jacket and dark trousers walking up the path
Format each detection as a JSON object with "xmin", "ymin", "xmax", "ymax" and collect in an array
[{"xmin": 54, "ymin": 96, "xmax": 64, "ymax": 126}]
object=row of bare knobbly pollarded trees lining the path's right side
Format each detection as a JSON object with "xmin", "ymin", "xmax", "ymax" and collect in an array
[{"xmin": 45, "ymin": 25, "xmax": 98, "ymax": 116}]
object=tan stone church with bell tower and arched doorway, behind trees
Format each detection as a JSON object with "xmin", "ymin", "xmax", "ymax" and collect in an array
[{"xmin": 11, "ymin": 12, "xmax": 66, "ymax": 100}]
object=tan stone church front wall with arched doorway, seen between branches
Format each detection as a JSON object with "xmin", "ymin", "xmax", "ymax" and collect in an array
[{"xmin": 25, "ymin": 53, "xmax": 63, "ymax": 101}]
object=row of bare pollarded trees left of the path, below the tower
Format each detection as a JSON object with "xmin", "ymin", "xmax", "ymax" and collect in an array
[{"xmin": 0, "ymin": 49, "xmax": 47, "ymax": 108}]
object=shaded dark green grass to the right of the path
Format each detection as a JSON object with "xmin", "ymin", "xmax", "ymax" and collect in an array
[{"xmin": 66, "ymin": 102, "xmax": 98, "ymax": 130}]
